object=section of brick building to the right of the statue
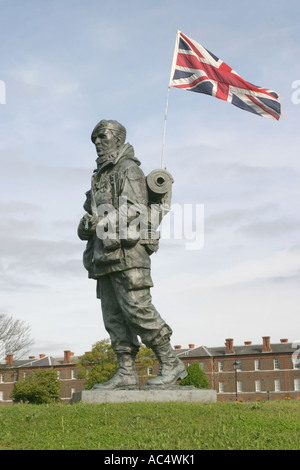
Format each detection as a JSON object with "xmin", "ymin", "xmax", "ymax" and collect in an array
[{"xmin": 175, "ymin": 336, "xmax": 300, "ymax": 401}]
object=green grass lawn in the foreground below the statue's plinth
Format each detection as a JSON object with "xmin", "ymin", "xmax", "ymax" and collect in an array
[{"xmin": 0, "ymin": 401, "xmax": 300, "ymax": 450}]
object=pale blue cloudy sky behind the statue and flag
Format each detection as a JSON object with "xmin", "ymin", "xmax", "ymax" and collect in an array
[{"xmin": 0, "ymin": 0, "xmax": 300, "ymax": 355}]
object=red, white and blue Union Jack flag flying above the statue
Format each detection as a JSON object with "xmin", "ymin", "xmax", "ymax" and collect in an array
[{"xmin": 169, "ymin": 31, "xmax": 281, "ymax": 120}]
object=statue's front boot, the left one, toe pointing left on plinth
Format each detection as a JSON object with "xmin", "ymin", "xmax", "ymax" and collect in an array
[{"xmin": 93, "ymin": 353, "xmax": 139, "ymax": 390}]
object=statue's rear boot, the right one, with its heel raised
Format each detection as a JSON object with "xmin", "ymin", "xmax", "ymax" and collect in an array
[{"xmin": 147, "ymin": 342, "xmax": 187, "ymax": 385}]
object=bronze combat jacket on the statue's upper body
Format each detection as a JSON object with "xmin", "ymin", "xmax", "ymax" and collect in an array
[{"xmin": 78, "ymin": 144, "xmax": 158, "ymax": 289}]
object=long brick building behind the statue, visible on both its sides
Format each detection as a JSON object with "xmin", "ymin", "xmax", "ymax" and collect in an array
[{"xmin": 0, "ymin": 336, "xmax": 300, "ymax": 405}]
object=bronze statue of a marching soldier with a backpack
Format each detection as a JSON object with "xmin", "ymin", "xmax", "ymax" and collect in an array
[{"xmin": 78, "ymin": 120, "xmax": 187, "ymax": 389}]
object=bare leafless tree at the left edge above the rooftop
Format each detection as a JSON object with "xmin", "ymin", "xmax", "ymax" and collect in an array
[{"xmin": 0, "ymin": 314, "xmax": 33, "ymax": 359}]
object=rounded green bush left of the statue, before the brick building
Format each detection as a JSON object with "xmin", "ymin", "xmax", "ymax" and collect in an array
[{"xmin": 11, "ymin": 370, "xmax": 60, "ymax": 405}]
